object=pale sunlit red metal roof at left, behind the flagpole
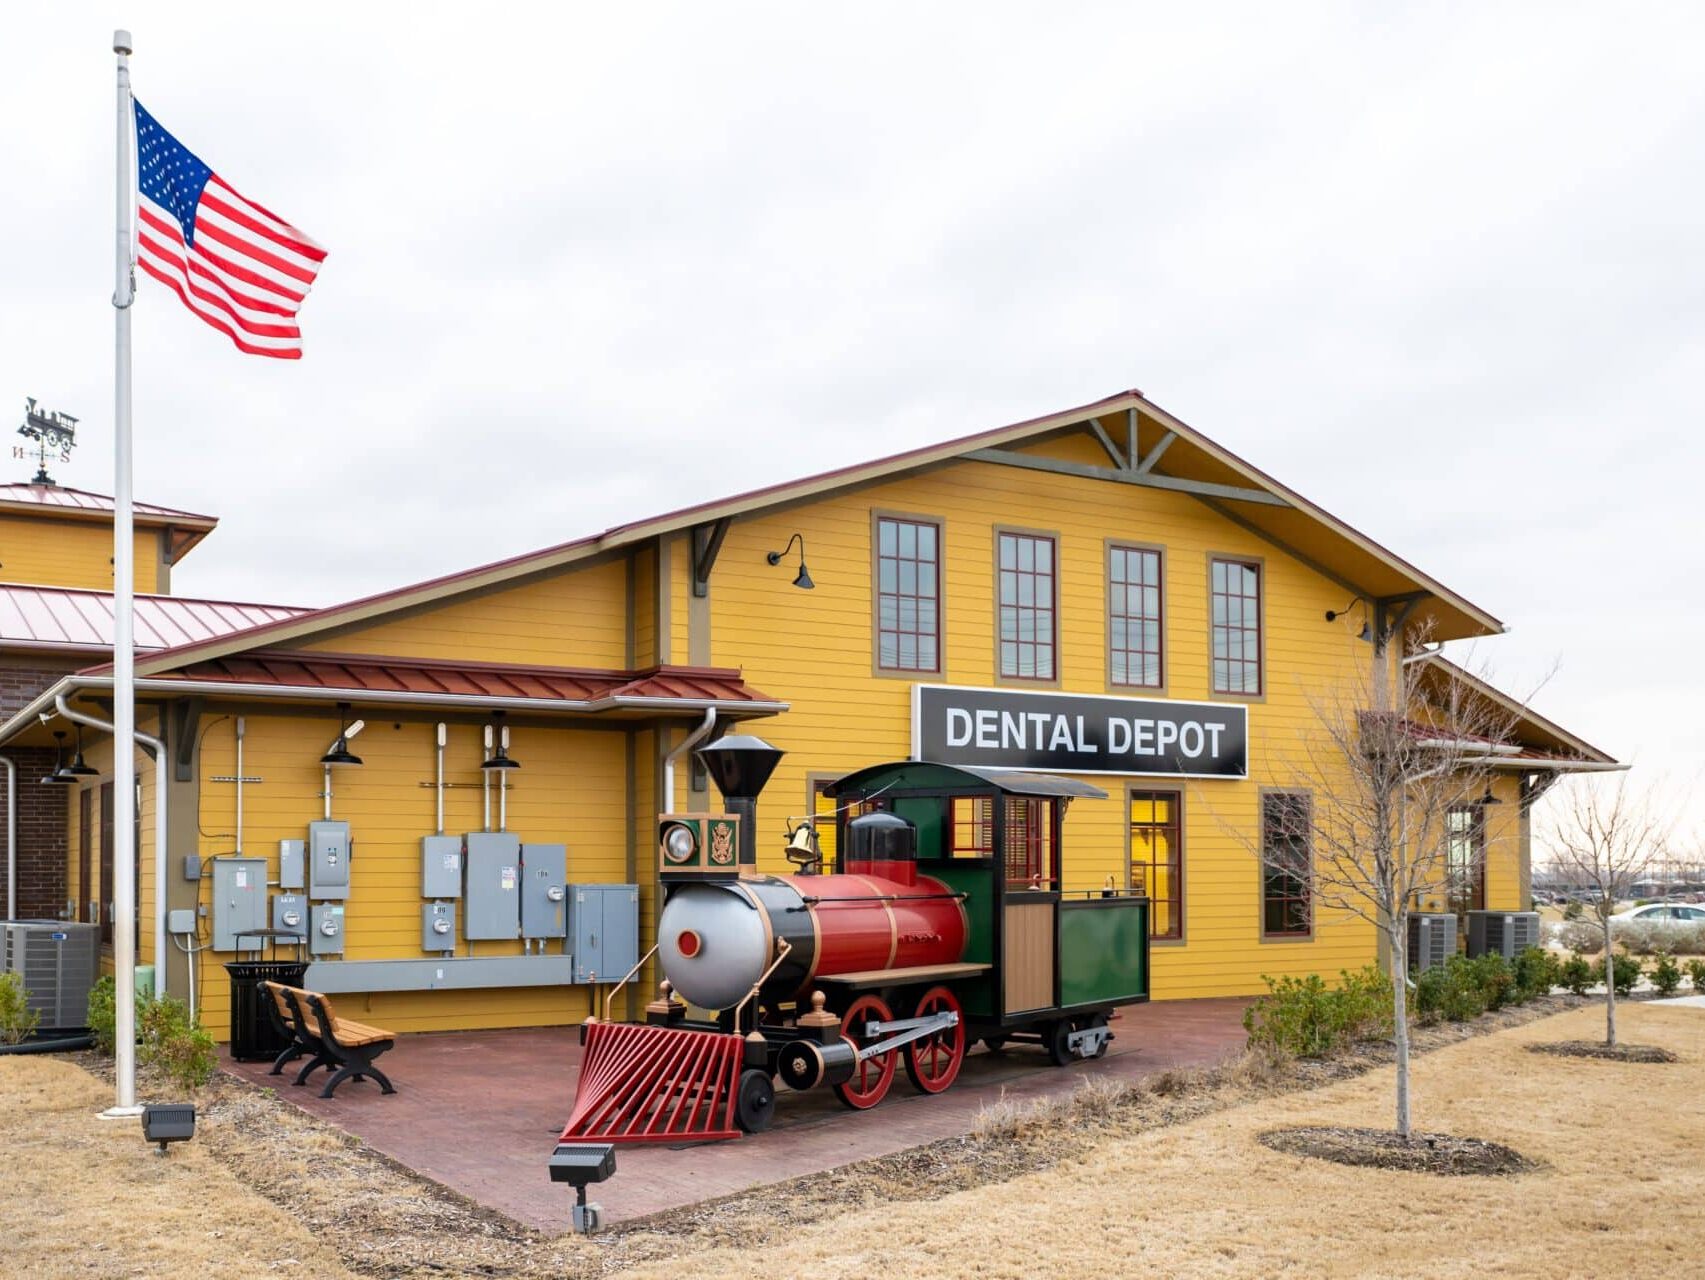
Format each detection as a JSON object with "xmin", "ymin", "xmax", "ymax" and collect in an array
[{"xmin": 0, "ymin": 583, "xmax": 309, "ymax": 651}]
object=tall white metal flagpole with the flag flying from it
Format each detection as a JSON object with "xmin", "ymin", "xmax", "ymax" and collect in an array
[{"xmin": 102, "ymin": 31, "xmax": 142, "ymax": 1118}]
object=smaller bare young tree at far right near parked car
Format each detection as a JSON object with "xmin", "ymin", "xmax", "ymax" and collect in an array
[{"xmin": 1541, "ymin": 774, "xmax": 1673, "ymax": 1045}]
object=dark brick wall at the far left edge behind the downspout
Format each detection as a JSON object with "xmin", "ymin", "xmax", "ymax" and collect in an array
[{"xmin": 0, "ymin": 660, "xmax": 75, "ymax": 919}]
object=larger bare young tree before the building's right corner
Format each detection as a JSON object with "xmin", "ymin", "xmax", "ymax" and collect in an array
[{"xmin": 1258, "ymin": 637, "xmax": 1516, "ymax": 1139}]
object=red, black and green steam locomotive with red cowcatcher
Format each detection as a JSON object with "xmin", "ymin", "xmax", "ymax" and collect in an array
[{"xmin": 563, "ymin": 736, "xmax": 1149, "ymax": 1142}]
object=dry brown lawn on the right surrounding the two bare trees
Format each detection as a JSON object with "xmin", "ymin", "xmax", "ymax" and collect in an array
[{"xmin": 629, "ymin": 1004, "xmax": 1705, "ymax": 1280}]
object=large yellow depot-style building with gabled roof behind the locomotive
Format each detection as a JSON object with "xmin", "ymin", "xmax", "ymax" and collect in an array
[{"xmin": 0, "ymin": 392, "xmax": 1613, "ymax": 1029}]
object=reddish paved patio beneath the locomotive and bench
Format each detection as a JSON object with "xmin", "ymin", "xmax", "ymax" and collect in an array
[{"xmin": 223, "ymin": 999, "xmax": 1248, "ymax": 1231}]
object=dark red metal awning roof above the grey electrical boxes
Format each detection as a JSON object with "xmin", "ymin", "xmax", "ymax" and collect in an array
[{"xmin": 148, "ymin": 651, "xmax": 783, "ymax": 711}]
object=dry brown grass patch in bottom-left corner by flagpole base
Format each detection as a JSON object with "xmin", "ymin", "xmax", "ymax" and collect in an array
[{"xmin": 0, "ymin": 1057, "xmax": 351, "ymax": 1280}]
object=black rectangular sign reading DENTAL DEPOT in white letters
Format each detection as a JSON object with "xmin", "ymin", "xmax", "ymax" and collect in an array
[{"xmin": 912, "ymin": 685, "xmax": 1250, "ymax": 777}]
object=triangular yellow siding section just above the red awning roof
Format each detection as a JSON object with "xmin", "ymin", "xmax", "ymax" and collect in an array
[{"xmin": 300, "ymin": 559, "xmax": 627, "ymax": 668}]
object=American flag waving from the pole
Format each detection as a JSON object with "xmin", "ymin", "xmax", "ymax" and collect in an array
[{"xmin": 136, "ymin": 102, "xmax": 326, "ymax": 360}]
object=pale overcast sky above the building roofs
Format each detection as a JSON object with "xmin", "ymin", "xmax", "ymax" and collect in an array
[{"xmin": 0, "ymin": 0, "xmax": 1705, "ymax": 841}]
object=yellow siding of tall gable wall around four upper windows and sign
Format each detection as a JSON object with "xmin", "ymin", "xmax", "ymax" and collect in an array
[{"xmin": 711, "ymin": 460, "xmax": 1376, "ymax": 999}]
